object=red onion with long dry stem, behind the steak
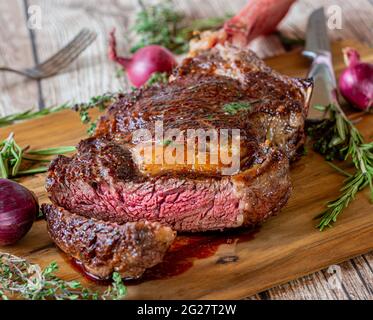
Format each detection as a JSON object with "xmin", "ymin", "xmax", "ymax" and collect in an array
[{"xmin": 109, "ymin": 30, "xmax": 176, "ymax": 87}]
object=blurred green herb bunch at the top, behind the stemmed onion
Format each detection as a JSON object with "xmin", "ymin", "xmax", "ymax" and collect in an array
[{"xmin": 131, "ymin": 0, "xmax": 227, "ymax": 54}]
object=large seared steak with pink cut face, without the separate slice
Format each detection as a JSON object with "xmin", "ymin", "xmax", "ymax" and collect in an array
[{"xmin": 43, "ymin": 45, "xmax": 312, "ymax": 274}]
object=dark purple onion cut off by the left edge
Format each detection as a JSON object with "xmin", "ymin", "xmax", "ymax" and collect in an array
[{"xmin": 0, "ymin": 179, "xmax": 39, "ymax": 246}]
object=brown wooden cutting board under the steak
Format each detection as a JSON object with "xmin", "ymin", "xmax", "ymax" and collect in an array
[{"xmin": 0, "ymin": 41, "xmax": 373, "ymax": 299}]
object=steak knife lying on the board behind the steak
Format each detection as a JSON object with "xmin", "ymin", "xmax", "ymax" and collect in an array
[{"xmin": 303, "ymin": 8, "xmax": 337, "ymax": 118}]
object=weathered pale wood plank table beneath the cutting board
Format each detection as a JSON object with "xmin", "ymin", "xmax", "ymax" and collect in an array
[{"xmin": 0, "ymin": 0, "xmax": 373, "ymax": 299}]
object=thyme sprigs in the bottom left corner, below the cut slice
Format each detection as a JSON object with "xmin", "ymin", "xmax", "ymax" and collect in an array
[{"xmin": 0, "ymin": 252, "xmax": 127, "ymax": 300}]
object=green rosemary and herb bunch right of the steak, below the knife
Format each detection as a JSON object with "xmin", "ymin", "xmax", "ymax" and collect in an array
[{"xmin": 308, "ymin": 103, "xmax": 373, "ymax": 230}]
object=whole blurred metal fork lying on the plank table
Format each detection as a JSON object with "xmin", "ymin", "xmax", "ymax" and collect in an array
[{"xmin": 0, "ymin": 28, "xmax": 97, "ymax": 80}]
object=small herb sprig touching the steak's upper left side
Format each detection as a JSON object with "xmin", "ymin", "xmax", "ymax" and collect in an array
[{"xmin": 72, "ymin": 93, "xmax": 121, "ymax": 135}]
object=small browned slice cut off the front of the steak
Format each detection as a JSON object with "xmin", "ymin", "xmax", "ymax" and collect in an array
[{"xmin": 41, "ymin": 204, "xmax": 176, "ymax": 279}]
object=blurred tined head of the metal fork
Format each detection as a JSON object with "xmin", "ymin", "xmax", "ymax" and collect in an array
[{"xmin": 36, "ymin": 29, "xmax": 96, "ymax": 71}]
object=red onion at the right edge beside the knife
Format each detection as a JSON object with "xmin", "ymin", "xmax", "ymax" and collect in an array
[{"xmin": 339, "ymin": 48, "xmax": 373, "ymax": 111}]
